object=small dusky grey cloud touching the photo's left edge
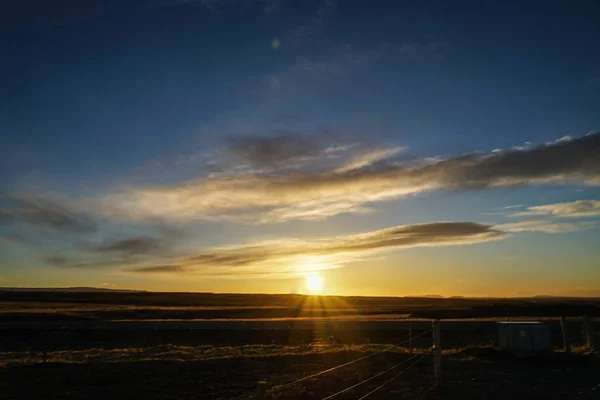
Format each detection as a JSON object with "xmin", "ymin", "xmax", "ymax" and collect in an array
[{"xmin": 0, "ymin": 196, "xmax": 97, "ymax": 233}]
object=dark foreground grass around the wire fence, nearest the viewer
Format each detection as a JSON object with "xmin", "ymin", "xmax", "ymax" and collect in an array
[{"xmin": 0, "ymin": 346, "xmax": 600, "ymax": 399}]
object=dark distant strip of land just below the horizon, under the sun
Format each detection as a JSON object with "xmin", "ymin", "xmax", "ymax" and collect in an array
[{"xmin": 0, "ymin": 290, "xmax": 600, "ymax": 322}]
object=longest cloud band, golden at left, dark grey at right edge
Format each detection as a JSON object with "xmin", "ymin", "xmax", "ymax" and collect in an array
[{"xmin": 100, "ymin": 133, "xmax": 600, "ymax": 222}]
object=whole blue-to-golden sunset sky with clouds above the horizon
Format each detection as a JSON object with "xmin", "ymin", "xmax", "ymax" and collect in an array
[{"xmin": 0, "ymin": 0, "xmax": 600, "ymax": 297}]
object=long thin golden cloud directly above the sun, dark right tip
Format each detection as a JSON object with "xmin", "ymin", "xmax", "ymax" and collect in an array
[{"xmin": 130, "ymin": 222, "xmax": 507, "ymax": 276}]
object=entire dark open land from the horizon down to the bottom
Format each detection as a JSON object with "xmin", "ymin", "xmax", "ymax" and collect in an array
[{"xmin": 0, "ymin": 292, "xmax": 600, "ymax": 400}]
